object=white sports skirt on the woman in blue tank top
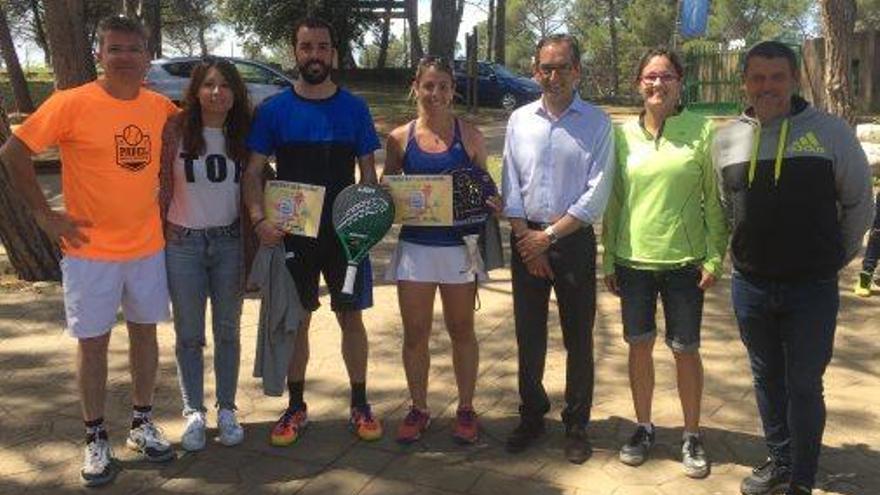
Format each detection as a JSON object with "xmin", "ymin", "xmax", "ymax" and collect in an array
[{"xmin": 385, "ymin": 241, "xmax": 489, "ymax": 284}]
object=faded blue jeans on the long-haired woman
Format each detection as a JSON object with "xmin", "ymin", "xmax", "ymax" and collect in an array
[{"xmin": 165, "ymin": 223, "xmax": 242, "ymax": 414}]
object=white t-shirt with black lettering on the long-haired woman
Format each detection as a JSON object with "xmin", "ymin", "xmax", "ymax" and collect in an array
[{"xmin": 168, "ymin": 127, "xmax": 241, "ymax": 229}]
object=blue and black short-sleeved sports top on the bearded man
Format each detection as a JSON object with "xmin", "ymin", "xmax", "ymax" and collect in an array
[{"xmin": 247, "ymin": 88, "xmax": 380, "ymax": 233}]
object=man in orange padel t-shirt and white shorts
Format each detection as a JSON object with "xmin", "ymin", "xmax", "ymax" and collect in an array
[{"xmin": 0, "ymin": 17, "xmax": 176, "ymax": 486}]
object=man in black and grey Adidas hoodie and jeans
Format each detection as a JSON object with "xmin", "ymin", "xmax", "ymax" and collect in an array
[{"xmin": 714, "ymin": 42, "xmax": 874, "ymax": 495}]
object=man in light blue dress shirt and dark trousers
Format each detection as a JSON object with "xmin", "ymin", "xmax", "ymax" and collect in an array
[{"xmin": 502, "ymin": 35, "xmax": 614, "ymax": 464}]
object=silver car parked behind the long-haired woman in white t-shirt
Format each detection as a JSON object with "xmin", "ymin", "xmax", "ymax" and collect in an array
[{"xmin": 144, "ymin": 57, "xmax": 293, "ymax": 107}]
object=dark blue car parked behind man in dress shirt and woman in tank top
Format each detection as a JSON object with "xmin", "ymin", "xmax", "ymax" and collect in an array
[{"xmin": 453, "ymin": 60, "xmax": 541, "ymax": 110}]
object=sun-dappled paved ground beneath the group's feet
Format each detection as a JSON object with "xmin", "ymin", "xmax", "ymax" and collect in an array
[{"xmin": 0, "ymin": 228, "xmax": 880, "ymax": 495}]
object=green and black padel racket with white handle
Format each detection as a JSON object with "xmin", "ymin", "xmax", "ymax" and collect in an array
[{"xmin": 333, "ymin": 184, "xmax": 394, "ymax": 295}]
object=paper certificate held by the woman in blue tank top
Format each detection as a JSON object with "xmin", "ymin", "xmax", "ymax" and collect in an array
[{"xmin": 385, "ymin": 175, "xmax": 452, "ymax": 227}]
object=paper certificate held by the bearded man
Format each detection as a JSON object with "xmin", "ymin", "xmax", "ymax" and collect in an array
[{"xmin": 263, "ymin": 180, "xmax": 324, "ymax": 238}]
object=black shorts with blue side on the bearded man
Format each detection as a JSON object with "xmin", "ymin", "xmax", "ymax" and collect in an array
[{"xmin": 284, "ymin": 229, "xmax": 373, "ymax": 311}]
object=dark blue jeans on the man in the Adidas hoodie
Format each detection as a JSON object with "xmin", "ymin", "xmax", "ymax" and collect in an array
[{"xmin": 731, "ymin": 272, "xmax": 840, "ymax": 487}]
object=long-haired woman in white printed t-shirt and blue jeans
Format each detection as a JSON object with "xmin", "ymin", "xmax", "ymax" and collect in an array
[{"xmin": 160, "ymin": 58, "xmax": 251, "ymax": 451}]
